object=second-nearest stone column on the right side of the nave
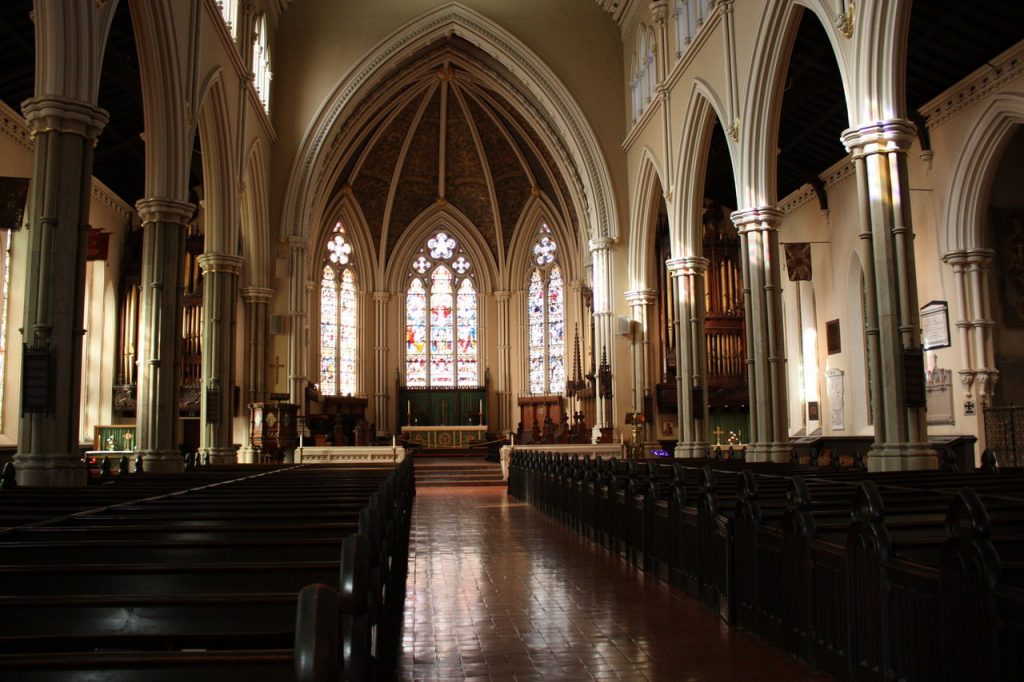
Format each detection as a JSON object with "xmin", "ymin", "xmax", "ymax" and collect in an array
[{"xmin": 731, "ymin": 206, "xmax": 790, "ymax": 462}]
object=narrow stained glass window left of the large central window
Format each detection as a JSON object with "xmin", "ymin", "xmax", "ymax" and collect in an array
[{"xmin": 319, "ymin": 223, "xmax": 358, "ymax": 395}]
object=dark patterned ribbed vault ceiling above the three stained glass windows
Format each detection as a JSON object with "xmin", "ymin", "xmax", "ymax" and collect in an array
[{"xmin": 323, "ymin": 38, "xmax": 579, "ymax": 262}]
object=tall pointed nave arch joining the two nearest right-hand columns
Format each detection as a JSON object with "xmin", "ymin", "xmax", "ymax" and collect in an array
[{"xmin": 741, "ymin": 0, "xmax": 851, "ymax": 204}]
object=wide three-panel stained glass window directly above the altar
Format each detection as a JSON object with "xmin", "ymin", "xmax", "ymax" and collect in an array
[{"xmin": 406, "ymin": 230, "xmax": 480, "ymax": 386}]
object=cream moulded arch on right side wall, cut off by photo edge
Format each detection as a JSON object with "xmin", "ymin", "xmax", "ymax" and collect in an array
[{"xmin": 943, "ymin": 92, "xmax": 1024, "ymax": 253}]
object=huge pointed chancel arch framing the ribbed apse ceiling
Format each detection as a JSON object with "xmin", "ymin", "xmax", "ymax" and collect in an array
[{"xmin": 282, "ymin": 2, "xmax": 618, "ymax": 249}]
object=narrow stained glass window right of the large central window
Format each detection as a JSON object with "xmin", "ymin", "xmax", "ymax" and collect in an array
[{"xmin": 526, "ymin": 223, "xmax": 565, "ymax": 394}]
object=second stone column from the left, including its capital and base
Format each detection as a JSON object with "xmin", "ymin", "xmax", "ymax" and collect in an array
[{"xmin": 135, "ymin": 199, "xmax": 196, "ymax": 471}]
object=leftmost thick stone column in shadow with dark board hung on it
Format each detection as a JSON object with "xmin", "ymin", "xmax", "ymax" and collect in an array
[{"xmin": 14, "ymin": 96, "xmax": 108, "ymax": 485}]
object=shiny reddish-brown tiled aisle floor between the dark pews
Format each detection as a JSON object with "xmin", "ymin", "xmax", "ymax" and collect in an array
[{"xmin": 399, "ymin": 487, "xmax": 831, "ymax": 682}]
